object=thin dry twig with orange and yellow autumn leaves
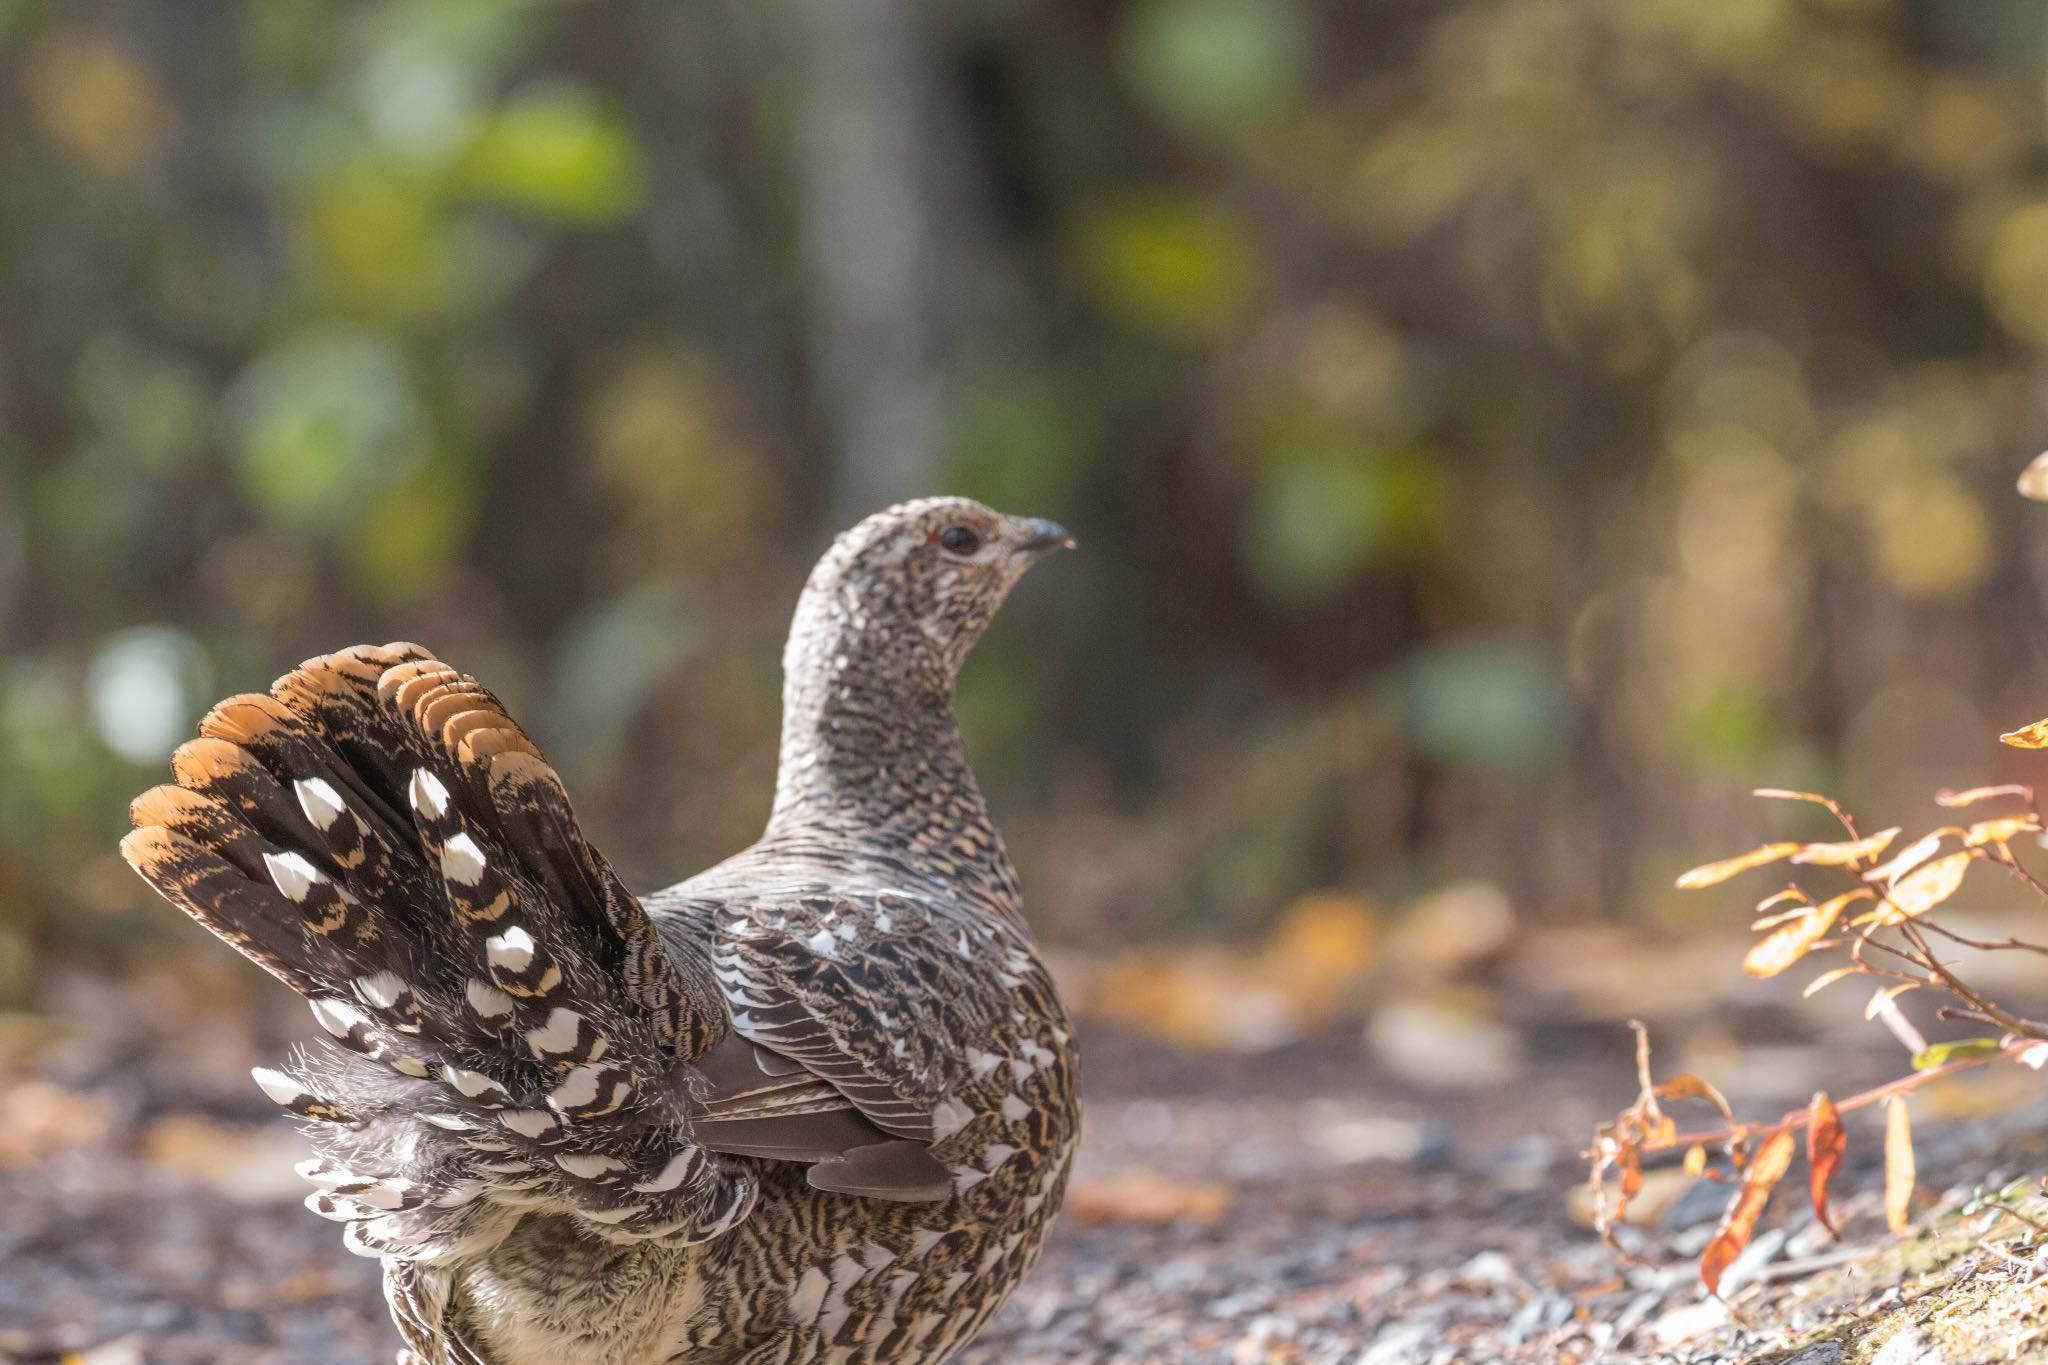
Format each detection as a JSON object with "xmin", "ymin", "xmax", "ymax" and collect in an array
[{"xmin": 1587, "ymin": 720, "xmax": 2048, "ymax": 1293}]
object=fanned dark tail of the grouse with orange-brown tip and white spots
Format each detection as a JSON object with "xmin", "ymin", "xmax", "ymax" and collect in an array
[{"xmin": 121, "ymin": 645, "xmax": 756, "ymax": 1259}]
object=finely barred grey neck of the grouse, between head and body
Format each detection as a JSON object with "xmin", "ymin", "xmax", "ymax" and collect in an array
[{"xmin": 768, "ymin": 602, "xmax": 1016, "ymax": 890}]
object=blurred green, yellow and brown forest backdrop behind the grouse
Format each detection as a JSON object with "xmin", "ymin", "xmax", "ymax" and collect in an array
[{"xmin": 0, "ymin": 0, "xmax": 2048, "ymax": 1031}]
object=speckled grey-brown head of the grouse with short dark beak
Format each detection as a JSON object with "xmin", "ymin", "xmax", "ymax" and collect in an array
[{"xmin": 791, "ymin": 497, "xmax": 1073, "ymax": 686}]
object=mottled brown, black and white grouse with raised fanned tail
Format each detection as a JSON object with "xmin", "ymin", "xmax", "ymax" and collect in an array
[{"xmin": 121, "ymin": 499, "xmax": 1079, "ymax": 1365}]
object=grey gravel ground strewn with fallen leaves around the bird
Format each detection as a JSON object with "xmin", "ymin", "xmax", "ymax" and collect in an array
[{"xmin": 0, "ymin": 986, "xmax": 2048, "ymax": 1365}]
